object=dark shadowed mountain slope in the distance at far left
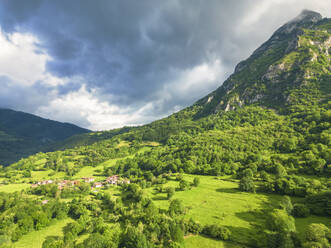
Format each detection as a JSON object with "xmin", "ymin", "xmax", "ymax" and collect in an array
[{"xmin": 0, "ymin": 109, "xmax": 90, "ymax": 165}]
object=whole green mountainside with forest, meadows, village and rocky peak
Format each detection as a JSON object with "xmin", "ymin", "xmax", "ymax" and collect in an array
[{"xmin": 0, "ymin": 11, "xmax": 331, "ymax": 248}]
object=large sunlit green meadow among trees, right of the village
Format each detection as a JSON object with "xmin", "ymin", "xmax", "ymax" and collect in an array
[{"xmin": 146, "ymin": 175, "xmax": 331, "ymax": 248}]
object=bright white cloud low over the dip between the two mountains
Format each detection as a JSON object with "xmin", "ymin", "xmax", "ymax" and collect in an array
[{"xmin": 36, "ymin": 85, "xmax": 165, "ymax": 130}]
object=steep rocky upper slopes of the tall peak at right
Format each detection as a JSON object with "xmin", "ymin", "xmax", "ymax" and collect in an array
[{"xmin": 195, "ymin": 10, "xmax": 331, "ymax": 117}]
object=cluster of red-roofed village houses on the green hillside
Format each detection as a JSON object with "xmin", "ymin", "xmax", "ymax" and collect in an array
[{"xmin": 31, "ymin": 175, "xmax": 130, "ymax": 190}]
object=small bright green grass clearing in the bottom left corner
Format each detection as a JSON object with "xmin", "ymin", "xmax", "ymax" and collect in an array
[{"xmin": 14, "ymin": 218, "xmax": 72, "ymax": 248}]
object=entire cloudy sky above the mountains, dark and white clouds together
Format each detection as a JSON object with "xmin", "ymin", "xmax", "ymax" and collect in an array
[{"xmin": 0, "ymin": 0, "xmax": 331, "ymax": 130}]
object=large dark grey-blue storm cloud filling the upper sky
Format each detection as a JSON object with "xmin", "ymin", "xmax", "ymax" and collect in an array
[{"xmin": 0, "ymin": 0, "xmax": 256, "ymax": 104}]
